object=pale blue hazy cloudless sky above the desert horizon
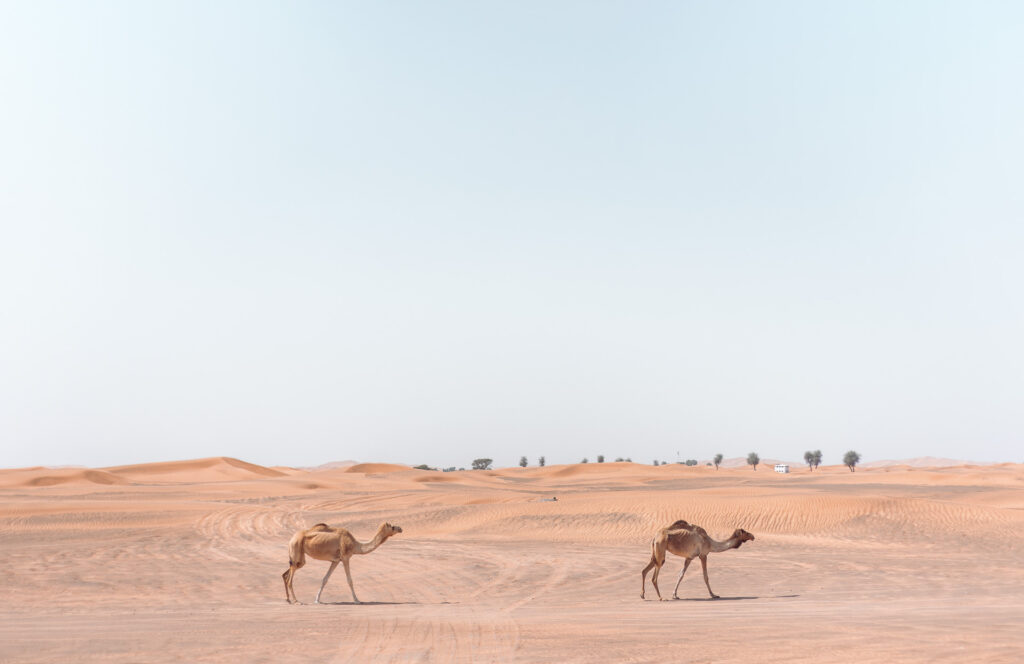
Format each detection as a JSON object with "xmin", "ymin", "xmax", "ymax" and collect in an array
[{"xmin": 0, "ymin": 0, "xmax": 1024, "ymax": 467}]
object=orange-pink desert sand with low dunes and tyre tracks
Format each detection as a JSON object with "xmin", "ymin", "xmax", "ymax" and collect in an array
[{"xmin": 0, "ymin": 458, "xmax": 1024, "ymax": 663}]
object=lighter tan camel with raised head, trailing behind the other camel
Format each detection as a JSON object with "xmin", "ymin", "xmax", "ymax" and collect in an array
[{"xmin": 282, "ymin": 524, "xmax": 401, "ymax": 604}]
